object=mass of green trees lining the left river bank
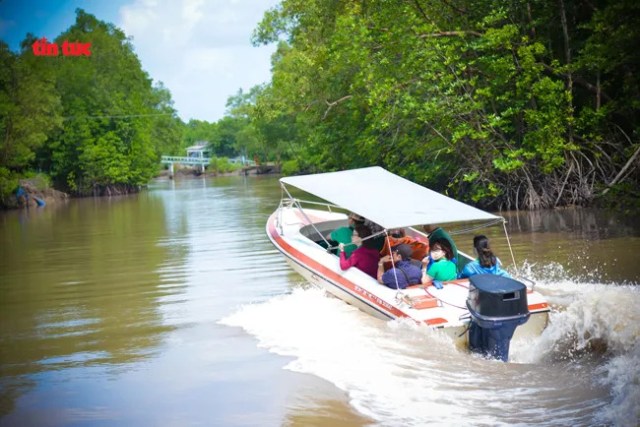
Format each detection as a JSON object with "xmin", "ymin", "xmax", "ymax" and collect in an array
[{"xmin": 0, "ymin": 10, "xmax": 183, "ymax": 205}]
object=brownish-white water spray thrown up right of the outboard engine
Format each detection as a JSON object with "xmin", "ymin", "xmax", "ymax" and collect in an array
[{"xmin": 513, "ymin": 265, "xmax": 640, "ymax": 426}]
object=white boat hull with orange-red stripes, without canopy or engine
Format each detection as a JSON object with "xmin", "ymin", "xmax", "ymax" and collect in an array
[{"xmin": 267, "ymin": 206, "xmax": 549, "ymax": 348}]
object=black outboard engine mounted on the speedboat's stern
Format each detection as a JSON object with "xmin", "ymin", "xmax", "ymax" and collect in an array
[{"xmin": 467, "ymin": 274, "xmax": 529, "ymax": 362}]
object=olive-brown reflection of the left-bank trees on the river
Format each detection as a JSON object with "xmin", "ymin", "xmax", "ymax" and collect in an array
[{"xmin": 0, "ymin": 195, "xmax": 184, "ymax": 413}]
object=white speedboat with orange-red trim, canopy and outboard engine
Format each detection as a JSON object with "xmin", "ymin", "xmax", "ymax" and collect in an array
[{"xmin": 266, "ymin": 167, "xmax": 550, "ymax": 361}]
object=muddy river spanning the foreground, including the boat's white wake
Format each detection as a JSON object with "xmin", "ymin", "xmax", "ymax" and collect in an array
[{"xmin": 0, "ymin": 177, "xmax": 640, "ymax": 426}]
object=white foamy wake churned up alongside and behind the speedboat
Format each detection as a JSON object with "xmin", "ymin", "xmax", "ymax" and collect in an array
[{"xmin": 220, "ymin": 272, "xmax": 640, "ymax": 426}]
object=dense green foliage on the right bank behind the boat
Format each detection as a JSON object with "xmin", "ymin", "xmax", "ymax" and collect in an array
[{"xmin": 245, "ymin": 0, "xmax": 640, "ymax": 208}]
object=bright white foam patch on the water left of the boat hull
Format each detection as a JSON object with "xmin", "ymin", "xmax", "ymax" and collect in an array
[{"xmin": 221, "ymin": 289, "xmax": 476, "ymax": 425}]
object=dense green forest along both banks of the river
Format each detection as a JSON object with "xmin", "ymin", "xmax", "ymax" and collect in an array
[{"xmin": 0, "ymin": 0, "xmax": 640, "ymax": 210}]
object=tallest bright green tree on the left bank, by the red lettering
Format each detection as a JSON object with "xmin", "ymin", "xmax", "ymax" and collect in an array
[{"xmin": 43, "ymin": 10, "xmax": 180, "ymax": 194}]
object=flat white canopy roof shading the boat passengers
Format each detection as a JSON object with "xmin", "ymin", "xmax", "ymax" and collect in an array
[{"xmin": 280, "ymin": 166, "xmax": 501, "ymax": 229}]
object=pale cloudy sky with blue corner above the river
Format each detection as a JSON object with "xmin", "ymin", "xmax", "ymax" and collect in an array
[{"xmin": 0, "ymin": 0, "xmax": 279, "ymax": 122}]
